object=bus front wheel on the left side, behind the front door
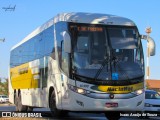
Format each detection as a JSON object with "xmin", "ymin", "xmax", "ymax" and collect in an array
[{"xmin": 49, "ymin": 91, "xmax": 63, "ymax": 117}]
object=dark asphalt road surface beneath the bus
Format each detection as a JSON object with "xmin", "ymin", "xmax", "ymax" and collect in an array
[{"xmin": 0, "ymin": 104, "xmax": 160, "ymax": 120}]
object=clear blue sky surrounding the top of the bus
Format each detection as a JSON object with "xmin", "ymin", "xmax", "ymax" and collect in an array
[{"xmin": 0, "ymin": 0, "xmax": 160, "ymax": 80}]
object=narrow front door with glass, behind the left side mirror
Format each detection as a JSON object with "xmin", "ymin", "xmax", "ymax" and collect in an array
[{"xmin": 54, "ymin": 22, "xmax": 69, "ymax": 108}]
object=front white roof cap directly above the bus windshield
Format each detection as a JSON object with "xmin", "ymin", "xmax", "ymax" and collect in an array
[{"xmin": 54, "ymin": 12, "xmax": 135, "ymax": 26}]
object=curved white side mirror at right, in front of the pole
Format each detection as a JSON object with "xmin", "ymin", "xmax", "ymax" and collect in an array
[{"xmin": 141, "ymin": 35, "xmax": 156, "ymax": 56}]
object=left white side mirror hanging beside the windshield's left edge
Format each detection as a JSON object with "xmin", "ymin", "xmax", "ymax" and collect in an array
[{"xmin": 62, "ymin": 31, "xmax": 71, "ymax": 53}]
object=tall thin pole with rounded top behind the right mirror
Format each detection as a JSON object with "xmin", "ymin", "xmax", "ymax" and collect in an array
[{"xmin": 145, "ymin": 27, "xmax": 152, "ymax": 79}]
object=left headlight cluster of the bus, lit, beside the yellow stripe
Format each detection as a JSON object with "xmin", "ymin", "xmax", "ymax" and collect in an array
[{"xmin": 68, "ymin": 84, "xmax": 90, "ymax": 95}]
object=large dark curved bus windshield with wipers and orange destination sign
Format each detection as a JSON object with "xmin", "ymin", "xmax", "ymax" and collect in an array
[{"xmin": 72, "ymin": 25, "xmax": 144, "ymax": 80}]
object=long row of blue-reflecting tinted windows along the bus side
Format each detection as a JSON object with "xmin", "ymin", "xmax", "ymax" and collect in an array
[{"xmin": 10, "ymin": 26, "xmax": 54, "ymax": 67}]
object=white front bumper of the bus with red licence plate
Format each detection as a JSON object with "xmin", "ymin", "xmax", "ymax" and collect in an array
[{"xmin": 62, "ymin": 91, "xmax": 144, "ymax": 112}]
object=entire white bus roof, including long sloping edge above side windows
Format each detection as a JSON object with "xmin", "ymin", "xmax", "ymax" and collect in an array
[{"xmin": 11, "ymin": 12, "xmax": 135, "ymax": 50}]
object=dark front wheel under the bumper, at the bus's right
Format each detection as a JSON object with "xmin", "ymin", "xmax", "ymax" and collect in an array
[{"xmin": 105, "ymin": 111, "xmax": 120, "ymax": 120}]
